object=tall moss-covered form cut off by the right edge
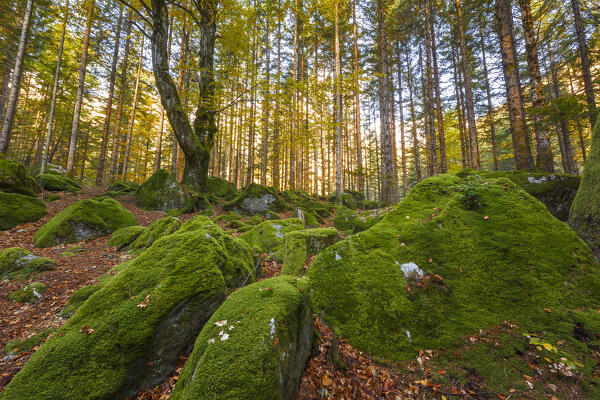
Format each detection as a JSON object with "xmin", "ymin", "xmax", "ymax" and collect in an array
[{"xmin": 569, "ymin": 118, "xmax": 600, "ymax": 258}]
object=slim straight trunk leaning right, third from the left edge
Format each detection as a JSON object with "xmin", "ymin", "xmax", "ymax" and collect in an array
[{"xmin": 66, "ymin": 0, "xmax": 95, "ymax": 175}]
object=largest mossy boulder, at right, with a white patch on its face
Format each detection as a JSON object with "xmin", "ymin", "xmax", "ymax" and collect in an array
[{"xmin": 308, "ymin": 175, "xmax": 600, "ymax": 368}]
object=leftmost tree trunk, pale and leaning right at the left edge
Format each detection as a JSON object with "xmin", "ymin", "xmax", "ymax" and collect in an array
[{"xmin": 0, "ymin": 0, "xmax": 33, "ymax": 155}]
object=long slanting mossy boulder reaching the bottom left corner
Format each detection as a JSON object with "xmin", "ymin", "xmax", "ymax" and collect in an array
[{"xmin": 2, "ymin": 221, "xmax": 254, "ymax": 400}]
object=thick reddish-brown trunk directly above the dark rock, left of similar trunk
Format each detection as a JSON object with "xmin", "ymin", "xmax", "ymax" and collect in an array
[{"xmin": 495, "ymin": 0, "xmax": 533, "ymax": 171}]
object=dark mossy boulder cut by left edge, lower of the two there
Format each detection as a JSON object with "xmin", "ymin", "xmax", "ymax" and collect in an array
[{"xmin": 0, "ymin": 192, "xmax": 46, "ymax": 231}]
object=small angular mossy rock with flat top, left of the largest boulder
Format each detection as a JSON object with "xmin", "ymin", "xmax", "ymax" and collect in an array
[{"xmin": 281, "ymin": 228, "xmax": 342, "ymax": 276}]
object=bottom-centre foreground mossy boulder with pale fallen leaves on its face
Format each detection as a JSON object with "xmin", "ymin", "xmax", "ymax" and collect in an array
[{"xmin": 171, "ymin": 276, "xmax": 313, "ymax": 400}]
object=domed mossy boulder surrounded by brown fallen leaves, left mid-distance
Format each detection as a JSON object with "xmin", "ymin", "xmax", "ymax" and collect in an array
[{"xmin": 35, "ymin": 197, "xmax": 137, "ymax": 247}]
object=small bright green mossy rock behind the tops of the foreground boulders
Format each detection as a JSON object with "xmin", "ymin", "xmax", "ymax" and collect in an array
[{"xmin": 239, "ymin": 218, "xmax": 304, "ymax": 253}]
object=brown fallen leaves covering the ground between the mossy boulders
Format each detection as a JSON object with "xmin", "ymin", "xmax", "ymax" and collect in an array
[{"xmin": 0, "ymin": 188, "xmax": 580, "ymax": 400}]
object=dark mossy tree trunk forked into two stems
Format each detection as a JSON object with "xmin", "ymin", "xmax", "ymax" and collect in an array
[{"xmin": 152, "ymin": 0, "xmax": 217, "ymax": 192}]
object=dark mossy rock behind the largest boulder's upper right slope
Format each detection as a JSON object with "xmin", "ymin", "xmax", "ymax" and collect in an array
[{"xmin": 456, "ymin": 169, "xmax": 581, "ymax": 221}]
